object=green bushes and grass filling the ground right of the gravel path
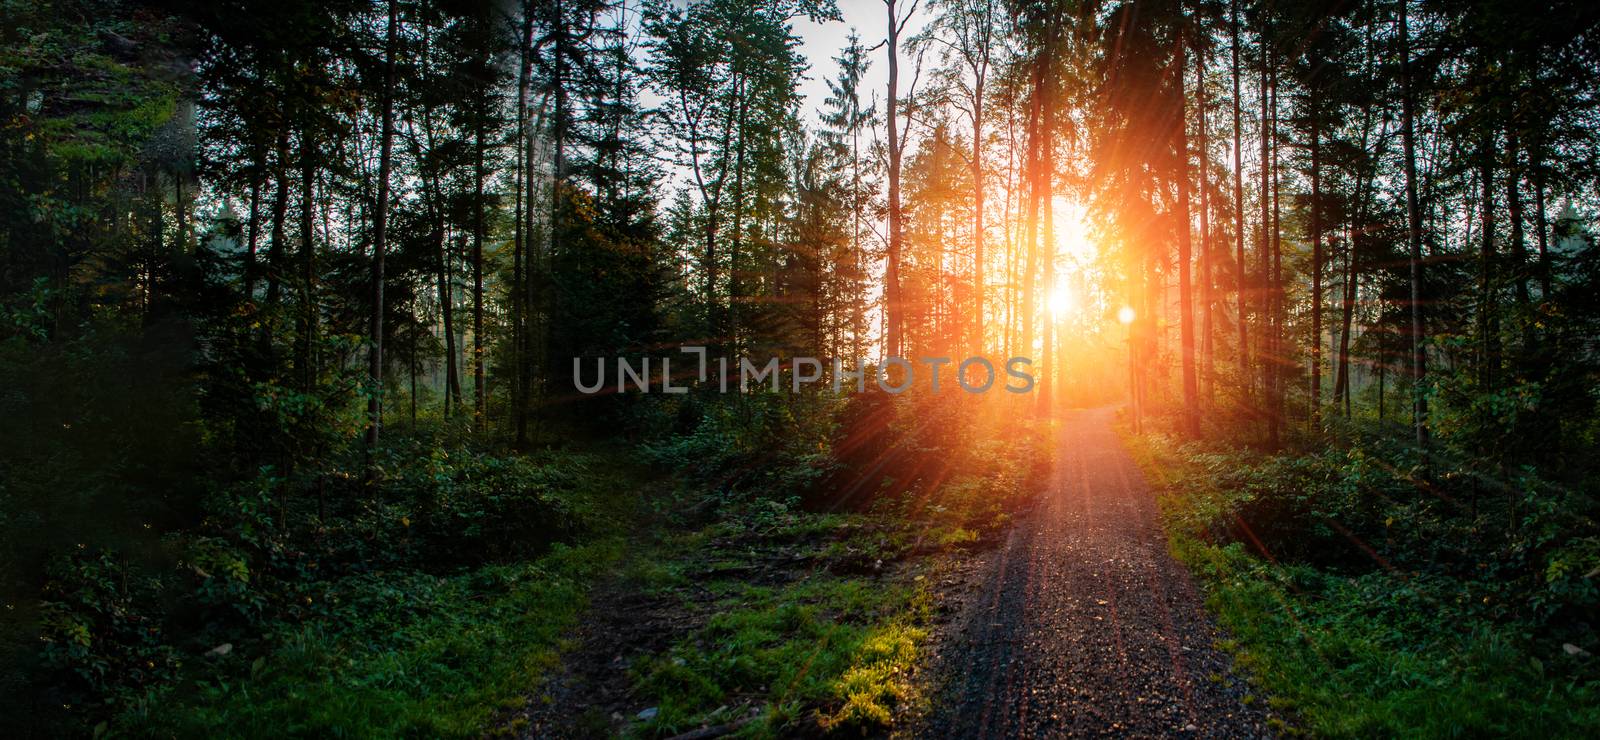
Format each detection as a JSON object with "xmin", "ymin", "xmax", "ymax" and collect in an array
[{"xmin": 1131, "ymin": 419, "xmax": 1600, "ymax": 737}]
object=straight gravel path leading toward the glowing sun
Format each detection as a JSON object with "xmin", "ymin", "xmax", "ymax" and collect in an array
[{"xmin": 915, "ymin": 408, "xmax": 1269, "ymax": 738}]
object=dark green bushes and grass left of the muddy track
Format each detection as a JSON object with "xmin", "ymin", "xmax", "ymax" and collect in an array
[{"xmin": 14, "ymin": 445, "xmax": 629, "ymax": 735}]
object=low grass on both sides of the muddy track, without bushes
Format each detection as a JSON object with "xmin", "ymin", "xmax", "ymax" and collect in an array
[{"xmin": 96, "ymin": 413, "xmax": 1032, "ymax": 737}]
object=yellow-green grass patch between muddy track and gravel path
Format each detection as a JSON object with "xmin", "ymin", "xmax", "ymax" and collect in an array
[{"xmin": 635, "ymin": 575, "xmax": 930, "ymax": 737}]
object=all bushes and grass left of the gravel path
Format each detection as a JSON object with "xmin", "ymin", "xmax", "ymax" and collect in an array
[{"xmin": 8, "ymin": 378, "xmax": 1048, "ymax": 737}]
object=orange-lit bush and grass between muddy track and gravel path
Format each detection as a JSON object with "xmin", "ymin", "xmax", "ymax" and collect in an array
[{"xmin": 610, "ymin": 387, "xmax": 1050, "ymax": 737}]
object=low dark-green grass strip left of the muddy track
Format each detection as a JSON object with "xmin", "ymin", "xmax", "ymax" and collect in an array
[{"xmin": 115, "ymin": 540, "xmax": 621, "ymax": 737}]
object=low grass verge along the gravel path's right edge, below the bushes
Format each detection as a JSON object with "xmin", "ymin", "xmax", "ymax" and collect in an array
[{"xmin": 1126, "ymin": 437, "xmax": 1600, "ymax": 737}]
